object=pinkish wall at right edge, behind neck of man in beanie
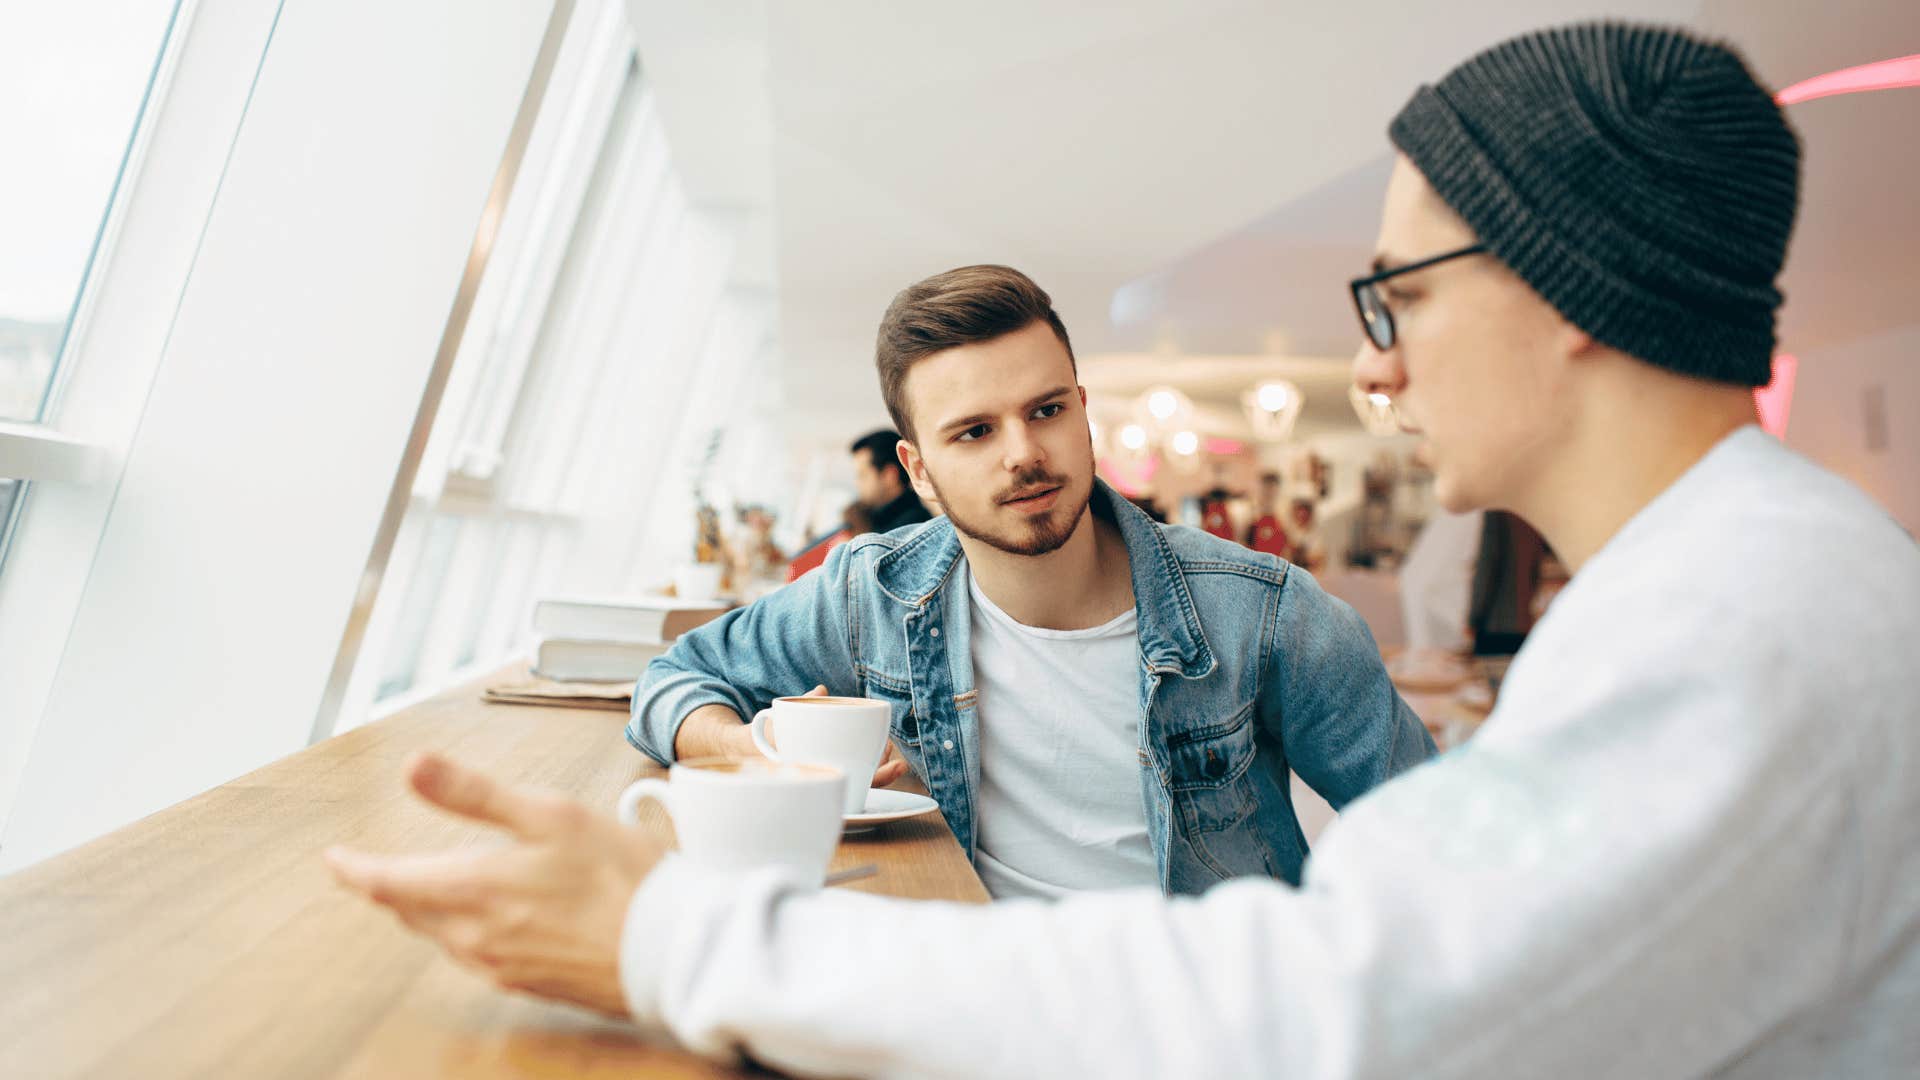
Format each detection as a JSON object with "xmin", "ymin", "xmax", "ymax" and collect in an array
[{"xmin": 1788, "ymin": 325, "xmax": 1920, "ymax": 536}]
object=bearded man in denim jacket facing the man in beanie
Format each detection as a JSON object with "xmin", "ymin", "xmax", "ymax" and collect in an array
[{"xmin": 628, "ymin": 267, "xmax": 1434, "ymax": 896}]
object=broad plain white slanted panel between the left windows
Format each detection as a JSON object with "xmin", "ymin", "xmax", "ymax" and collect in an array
[{"xmin": 0, "ymin": 0, "xmax": 551, "ymax": 869}]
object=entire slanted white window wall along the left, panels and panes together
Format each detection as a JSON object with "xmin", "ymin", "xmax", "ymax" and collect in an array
[{"xmin": 0, "ymin": 0, "xmax": 778, "ymax": 872}]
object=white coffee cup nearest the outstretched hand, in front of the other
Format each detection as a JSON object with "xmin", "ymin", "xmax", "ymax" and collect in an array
[{"xmin": 620, "ymin": 757, "xmax": 847, "ymax": 886}]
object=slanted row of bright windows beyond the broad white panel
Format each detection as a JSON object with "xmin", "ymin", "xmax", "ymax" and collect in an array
[{"xmin": 321, "ymin": 0, "xmax": 766, "ymax": 722}]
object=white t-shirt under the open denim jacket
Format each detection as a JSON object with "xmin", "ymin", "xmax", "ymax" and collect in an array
[{"xmin": 960, "ymin": 569, "xmax": 1158, "ymax": 897}]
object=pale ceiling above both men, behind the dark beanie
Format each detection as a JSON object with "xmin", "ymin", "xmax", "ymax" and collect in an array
[{"xmin": 628, "ymin": 0, "xmax": 1920, "ymax": 438}]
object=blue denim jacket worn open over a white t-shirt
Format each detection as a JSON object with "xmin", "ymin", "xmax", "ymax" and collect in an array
[{"xmin": 626, "ymin": 480, "xmax": 1434, "ymax": 894}]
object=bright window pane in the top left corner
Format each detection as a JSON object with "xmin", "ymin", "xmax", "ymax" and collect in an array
[{"xmin": 0, "ymin": 0, "xmax": 175, "ymax": 420}]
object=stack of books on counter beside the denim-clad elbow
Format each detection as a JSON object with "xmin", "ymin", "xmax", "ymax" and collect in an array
[{"xmin": 534, "ymin": 596, "xmax": 730, "ymax": 684}]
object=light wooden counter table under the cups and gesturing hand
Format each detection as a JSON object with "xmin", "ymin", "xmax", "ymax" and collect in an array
[{"xmin": 0, "ymin": 664, "xmax": 987, "ymax": 1078}]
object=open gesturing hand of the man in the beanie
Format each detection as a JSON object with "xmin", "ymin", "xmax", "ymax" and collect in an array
[{"xmin": 326, "ymin": 755, "xmax": 664, "ymax": 1017}]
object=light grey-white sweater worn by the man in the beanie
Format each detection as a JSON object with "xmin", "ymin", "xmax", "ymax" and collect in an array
[{"xmin": 622, "ymin": 429, "xmax": 1920, "ymax": 1080}]
